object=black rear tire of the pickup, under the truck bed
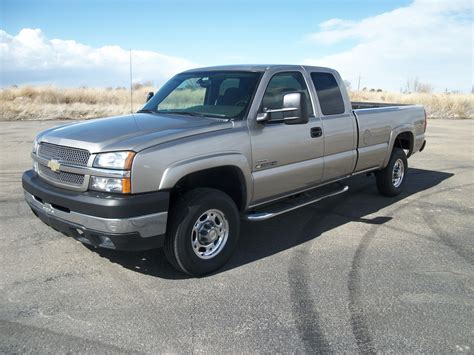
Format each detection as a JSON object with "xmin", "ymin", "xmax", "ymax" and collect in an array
[{"xmin": 375, "ymin": 148, "xmax": 408, "ymax": 197}]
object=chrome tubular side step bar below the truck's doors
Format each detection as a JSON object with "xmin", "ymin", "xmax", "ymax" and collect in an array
[{"xmin": 242, "ymin": 184, "xmax": 349, "ymax": 222}]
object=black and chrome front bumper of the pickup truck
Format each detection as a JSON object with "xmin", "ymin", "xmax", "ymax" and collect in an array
[{"xmin": 22, "ymin": 170, "xmax": 169, "ymax": 250}]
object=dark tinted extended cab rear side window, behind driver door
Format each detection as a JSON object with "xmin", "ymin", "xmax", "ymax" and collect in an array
[{"xmin": 311, "ymin": 73, "xmax": 345, "ymax": 116}]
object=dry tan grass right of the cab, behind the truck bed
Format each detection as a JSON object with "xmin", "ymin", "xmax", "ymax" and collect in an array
[{"xmin": 349, "ymin": 91, "xmax": 474, "ymax": 118}]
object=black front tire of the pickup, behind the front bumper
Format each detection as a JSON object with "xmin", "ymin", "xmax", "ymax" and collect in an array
[{"xmin": 164, "ymin": 188, "xmax": 240, "ymax": 276}]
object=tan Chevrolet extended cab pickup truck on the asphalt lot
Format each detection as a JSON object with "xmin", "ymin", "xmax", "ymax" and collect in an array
[{"xmin": 22, "ymin": 65, "xmax": 426, "ymax": 276}]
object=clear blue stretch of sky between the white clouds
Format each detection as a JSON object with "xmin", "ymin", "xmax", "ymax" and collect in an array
[{"xmin": 1, "ymin": 0, "xmax": 410, "ymax": 63}]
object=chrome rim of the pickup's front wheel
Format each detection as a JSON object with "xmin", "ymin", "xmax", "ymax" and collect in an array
[{"xmin": 191, "ymin": 209, "xmax": 229, "ymax": 259}]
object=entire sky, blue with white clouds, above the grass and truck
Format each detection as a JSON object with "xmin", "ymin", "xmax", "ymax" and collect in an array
[{"xmin": 0, "ymin": 0, "xmax": 473, "ymax": 92}]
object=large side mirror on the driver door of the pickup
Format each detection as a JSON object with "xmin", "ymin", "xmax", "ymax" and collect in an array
[{"xmin": 257, "ymin": 92, "xmax": 308, "ymax": 124}]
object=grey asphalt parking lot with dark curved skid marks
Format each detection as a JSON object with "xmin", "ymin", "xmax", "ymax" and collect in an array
[{"xmin": 0, "ymin": 120, "xmax": 474, "ymax": 353}]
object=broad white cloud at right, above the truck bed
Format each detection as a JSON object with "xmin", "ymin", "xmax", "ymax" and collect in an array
[{"xmin": 304, "ymin": 0, "xmax": 473, "ymax": 91}]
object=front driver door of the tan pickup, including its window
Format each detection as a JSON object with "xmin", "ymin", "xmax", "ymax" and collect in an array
[{"xmin": 249, "ymin": 70, "xmax": 324, "ymax": 205}]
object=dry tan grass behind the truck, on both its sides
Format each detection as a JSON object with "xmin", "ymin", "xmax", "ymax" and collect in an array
[{"xmin": 0, "ymin": 86, "xmax": 474, "ymax": 121}]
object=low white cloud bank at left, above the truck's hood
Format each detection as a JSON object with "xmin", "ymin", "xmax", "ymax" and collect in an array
[{"xmin": 0, "ymin": 28, "xmax": 195, "ymax": 86}]
